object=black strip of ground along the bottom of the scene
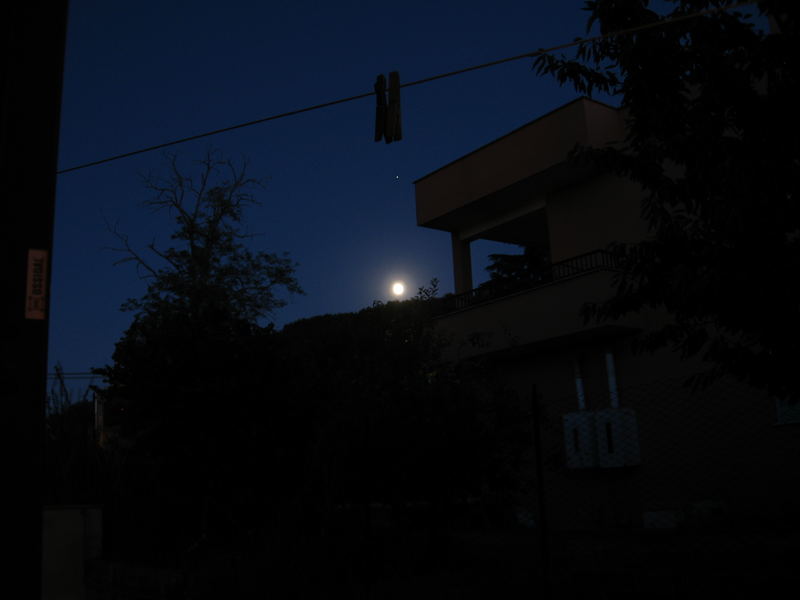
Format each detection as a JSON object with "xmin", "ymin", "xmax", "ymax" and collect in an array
[{"xmin": 87, "ymin": 530, "xmax": 800, "ymax": 600}]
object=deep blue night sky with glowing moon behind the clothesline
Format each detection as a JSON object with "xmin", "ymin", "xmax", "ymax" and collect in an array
[{"xmin": 49, "ymin": 0, "xmax": 620, "ymax": 371}]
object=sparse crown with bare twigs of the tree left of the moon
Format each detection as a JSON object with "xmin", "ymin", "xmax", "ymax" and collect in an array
[{"xmin": 107, "ymin": 151, "xmax": 303, "ymax": 323}]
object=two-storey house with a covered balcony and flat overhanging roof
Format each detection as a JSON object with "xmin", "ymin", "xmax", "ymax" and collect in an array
[{"xmin": 415, "ymin": 98, "xmax": 800, "ymax": 530}]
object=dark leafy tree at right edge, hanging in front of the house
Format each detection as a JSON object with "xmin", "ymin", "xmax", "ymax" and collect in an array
[{"xmin": 534, "ymin": 0, "xmax": 800, "ymax": 398}]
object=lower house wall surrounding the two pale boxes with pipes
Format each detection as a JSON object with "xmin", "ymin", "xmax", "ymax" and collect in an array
[{"xmin": 478, "ymin": 340, "xmax": 800, "ymax": 531}]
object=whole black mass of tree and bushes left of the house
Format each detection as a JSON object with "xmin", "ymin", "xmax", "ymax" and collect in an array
[{"xmin": 92, "ymin": 152, "xmax": 527, "ymax": 564}]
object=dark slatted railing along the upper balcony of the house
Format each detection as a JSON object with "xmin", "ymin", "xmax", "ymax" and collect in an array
[{"xmin": 440, "ymin": 250, "xmax": 619, "ymax": 314}]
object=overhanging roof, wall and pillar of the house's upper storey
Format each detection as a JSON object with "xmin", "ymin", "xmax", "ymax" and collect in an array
[{"xmin": 414, "ymin": 98, "xmax": 646, "ymax": 296}]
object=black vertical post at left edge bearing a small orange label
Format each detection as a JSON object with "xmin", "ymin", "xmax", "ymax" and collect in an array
[{"xmin": 0, "ymin": 0, "xmax": 67, "ymax": 600}]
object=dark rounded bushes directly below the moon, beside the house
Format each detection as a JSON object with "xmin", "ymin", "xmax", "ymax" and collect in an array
[{"xmin": 279, "ymin": 290, "xmax": 528, "ymax": 511}]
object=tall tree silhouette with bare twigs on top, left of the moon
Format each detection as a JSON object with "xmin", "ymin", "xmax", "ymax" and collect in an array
[{"xmin": 95, "ymin": 152, "xmax": 302, "ymax": 551}]
